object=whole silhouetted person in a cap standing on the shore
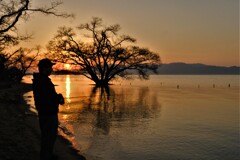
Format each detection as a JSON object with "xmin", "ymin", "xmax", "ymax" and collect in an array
[{"xmin": 33, "ymin": 58, "xmax": 64, "ymax": 160}]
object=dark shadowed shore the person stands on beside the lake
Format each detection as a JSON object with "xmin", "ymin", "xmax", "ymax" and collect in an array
[{"xmin": 0, "ymin": 83, "xmax": 85, "ymax": 160}]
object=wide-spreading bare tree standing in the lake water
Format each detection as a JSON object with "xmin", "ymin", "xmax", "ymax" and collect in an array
[{"xmin": 48, "ymin": 17, "xmax": 160, "ymax": 86}]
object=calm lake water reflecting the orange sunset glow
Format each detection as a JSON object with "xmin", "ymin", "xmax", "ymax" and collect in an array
[{"xmin": 24, "ymin": 75, "xmax": 240, "ymax": 160}]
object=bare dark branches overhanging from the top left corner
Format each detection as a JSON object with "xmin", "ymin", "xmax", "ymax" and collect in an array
[{"xmin": 0, "ymin": 0, "xmax": 73, "ymax": 48}]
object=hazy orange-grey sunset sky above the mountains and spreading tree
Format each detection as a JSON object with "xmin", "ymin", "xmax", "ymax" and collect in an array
[{"xmin": 20, "ymin": 0, "xmax": 240, "ymax": 66}]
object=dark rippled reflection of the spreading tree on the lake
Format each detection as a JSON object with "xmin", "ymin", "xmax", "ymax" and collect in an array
[{"xmin": 81, "ymin": 87, "xmax": 161, "ymax": 134}]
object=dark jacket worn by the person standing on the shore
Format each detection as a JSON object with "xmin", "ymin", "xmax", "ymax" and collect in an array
[{"xmin": 33, "ymin": 73, "xmax": 63, "ymax": 115}]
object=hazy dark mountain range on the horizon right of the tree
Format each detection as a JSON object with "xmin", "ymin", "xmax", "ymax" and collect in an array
[{"xmin": 158, "ymin": 62, "xmax": 240, "ymax": 75}]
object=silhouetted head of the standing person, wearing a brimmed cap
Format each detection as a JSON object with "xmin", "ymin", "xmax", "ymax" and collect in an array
[{"xmin": 38, "ymin": 58, "xmax": 55, "ymax": 76}]
